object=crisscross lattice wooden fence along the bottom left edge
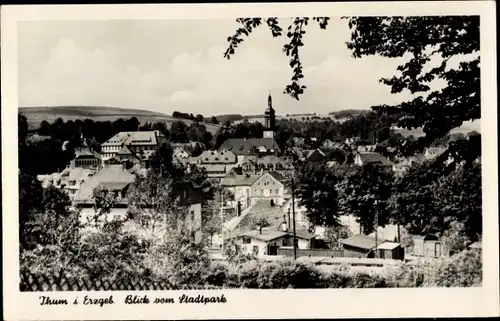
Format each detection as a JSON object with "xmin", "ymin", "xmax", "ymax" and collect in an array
[{"xmin": 20, "ymin": 272, "xmax": 221, "ymax": 292}]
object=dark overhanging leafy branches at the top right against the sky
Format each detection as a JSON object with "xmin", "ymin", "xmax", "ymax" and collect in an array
[{"xmin": 224, "ymin": 16, "xmax": 481, "ymax": 154}]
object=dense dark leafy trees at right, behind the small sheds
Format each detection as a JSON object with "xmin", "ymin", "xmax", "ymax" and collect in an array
[{"xmin": 295, "ymin": 151, "xmax": 482, "ymax": 250}]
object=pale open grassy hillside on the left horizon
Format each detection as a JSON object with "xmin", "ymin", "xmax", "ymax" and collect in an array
[{"xmin": 19, "ymin": 106, "xmax": 219, "ymax": 133}]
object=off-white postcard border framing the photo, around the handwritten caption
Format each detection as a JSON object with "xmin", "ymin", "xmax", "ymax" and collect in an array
[{"xmin": 1, "ymin": 1, "xmax": 499, "ymax": 320}]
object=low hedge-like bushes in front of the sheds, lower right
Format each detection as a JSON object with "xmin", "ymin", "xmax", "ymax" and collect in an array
[{"xmin": 201, "ymin": 250, "xmax": 482, "ymax": 289}]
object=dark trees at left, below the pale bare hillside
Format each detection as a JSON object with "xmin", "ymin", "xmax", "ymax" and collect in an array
[{"xmin": 18, "ymin": 114, "xmax": 213, "ymax": 175}]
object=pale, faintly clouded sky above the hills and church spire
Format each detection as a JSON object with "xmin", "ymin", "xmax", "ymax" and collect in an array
[{"xmin": 18, "ymin": 18, "xmax": 426, "ymax": 115}]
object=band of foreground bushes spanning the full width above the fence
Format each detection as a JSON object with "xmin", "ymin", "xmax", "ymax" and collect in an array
[{"xmin": 21, "ymin": 234, "xmax": 482, "ymax": 289}]
